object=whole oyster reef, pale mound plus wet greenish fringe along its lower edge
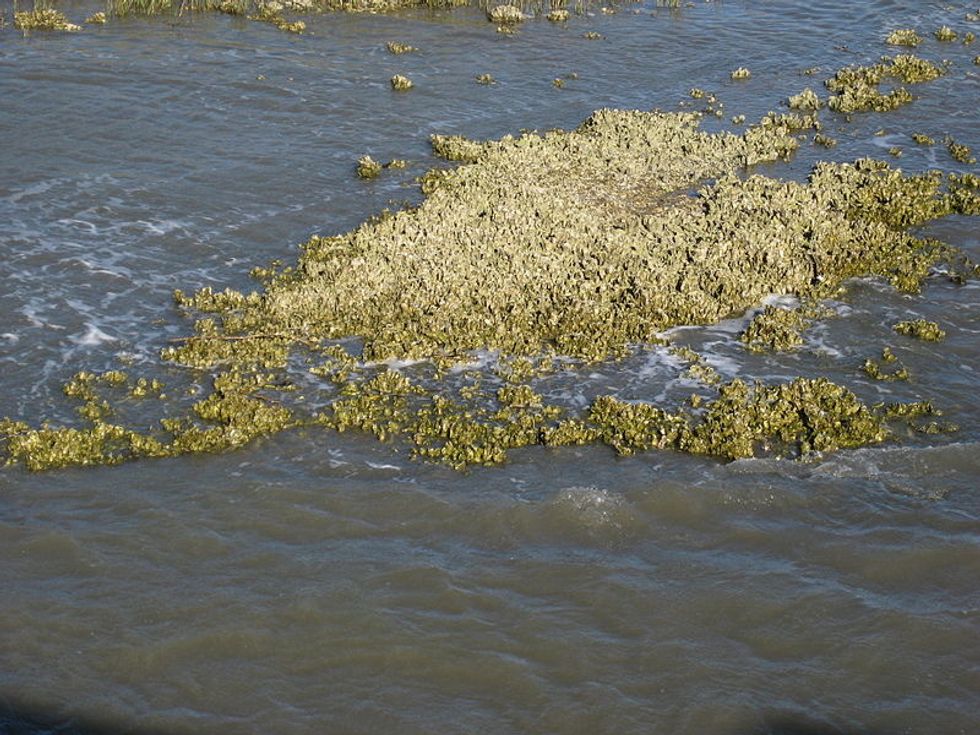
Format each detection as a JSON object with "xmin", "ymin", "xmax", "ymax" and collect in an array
[{"xmin": 0, "ymin": 50, "xmax": 980, "ymax": 470}]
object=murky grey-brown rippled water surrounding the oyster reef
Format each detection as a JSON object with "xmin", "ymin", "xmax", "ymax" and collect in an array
[{"xmin": 0, "ymin": 0, "xmax": 980, "ymax": 734}]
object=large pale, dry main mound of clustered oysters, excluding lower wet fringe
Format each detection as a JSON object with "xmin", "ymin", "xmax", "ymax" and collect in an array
[{"xmin": 170, "ymin": 110, "xmax": 976, "ymax": 367}]
